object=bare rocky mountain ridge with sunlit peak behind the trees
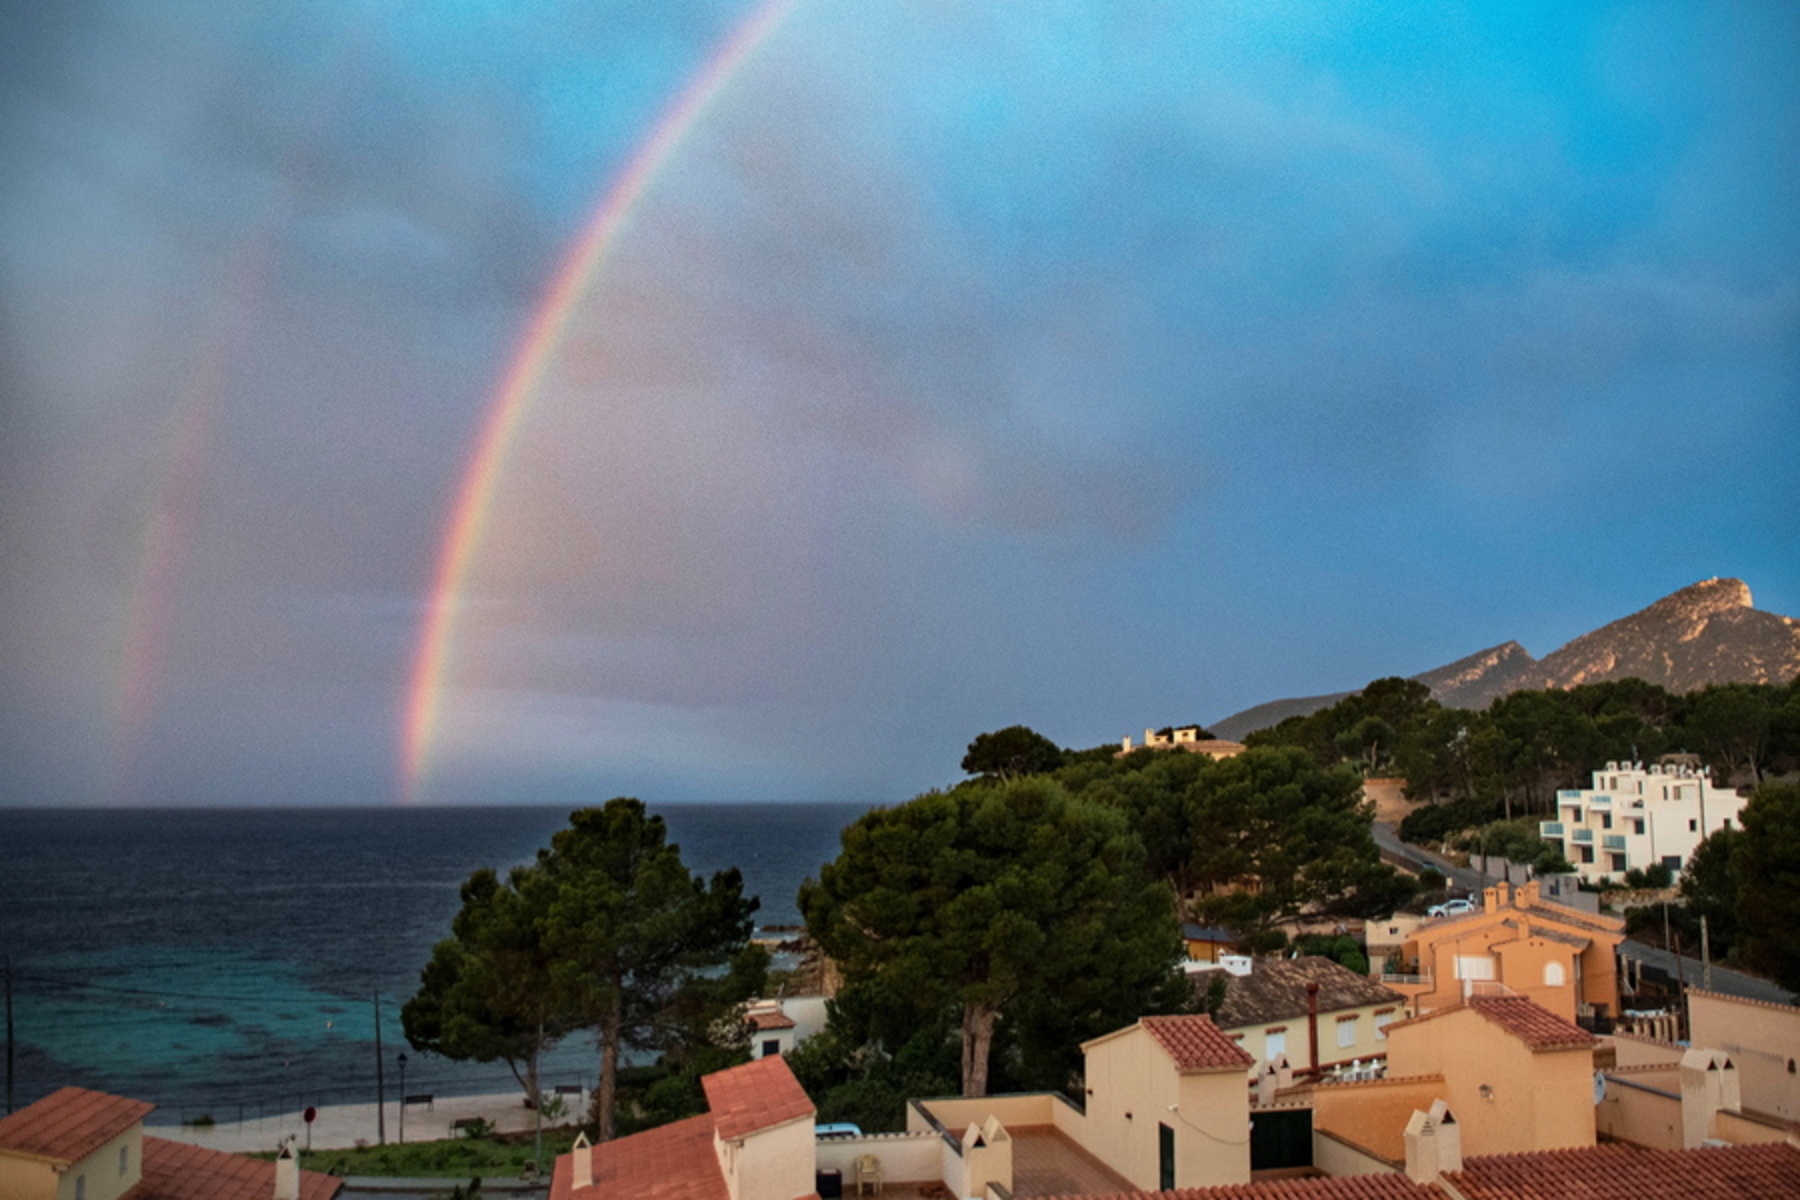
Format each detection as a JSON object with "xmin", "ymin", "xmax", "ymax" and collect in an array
[{"xmin": 1208, "ymin": 579, "xmax": 1800, "ymax": 738}]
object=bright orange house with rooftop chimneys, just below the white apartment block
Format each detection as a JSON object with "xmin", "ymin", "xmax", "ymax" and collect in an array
[{"xmin": 1382, "ymin": 882, "xmax": 1625, "ymax": 1020}]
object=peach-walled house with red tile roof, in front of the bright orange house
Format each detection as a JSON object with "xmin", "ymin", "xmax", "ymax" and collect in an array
[{"xmin": 1388, "ymin": 997, "xmax": 1595, "ymax": 1155}]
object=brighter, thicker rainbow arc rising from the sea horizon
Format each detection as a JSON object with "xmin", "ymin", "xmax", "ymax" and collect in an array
[{"xmin": 400, "ymin": 0, "xmax": 799, "ymax": 804}]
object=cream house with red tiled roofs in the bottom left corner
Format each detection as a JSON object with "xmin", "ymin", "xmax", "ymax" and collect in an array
[{"xmin": 0, "ymin": 1087, "xmax": 344, "ymax": 1200}]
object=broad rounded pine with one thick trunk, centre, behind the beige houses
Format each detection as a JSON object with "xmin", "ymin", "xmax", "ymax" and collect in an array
[{"xmin": 799, "ymin": 779, "xmax": 1181, "ymax": 1096}]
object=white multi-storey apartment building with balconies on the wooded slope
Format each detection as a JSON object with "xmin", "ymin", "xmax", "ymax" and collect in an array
[{"xmin": 1537, "ymin": 763, "xmax": 1744, "ymax": 882}]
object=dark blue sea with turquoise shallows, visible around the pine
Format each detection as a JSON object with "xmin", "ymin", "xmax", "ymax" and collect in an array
[{"xmin": 0, "ymin": 802, "xmax": 869, "ymax": 1124}]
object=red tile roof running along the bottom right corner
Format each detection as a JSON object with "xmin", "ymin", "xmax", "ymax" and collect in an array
[{"xmin": 1445, "ymin": 1144, "xmax": 1800, "ymax": 1200}]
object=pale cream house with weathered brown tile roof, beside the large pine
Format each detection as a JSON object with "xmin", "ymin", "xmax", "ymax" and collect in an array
[{"xmin": 1193, "ymin": 955, "xmax": 1406, "ymax": 1076}]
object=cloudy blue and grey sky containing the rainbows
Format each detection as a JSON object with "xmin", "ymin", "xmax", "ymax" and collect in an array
[{"xmin": 0, "ymin": 0, "xmax": 1800, "ymax": 806}]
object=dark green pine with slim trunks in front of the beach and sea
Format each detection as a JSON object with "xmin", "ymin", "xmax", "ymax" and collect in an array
[{"xmin": 401, "ymin": 799, "xmax": 769, "ymax": 1139}]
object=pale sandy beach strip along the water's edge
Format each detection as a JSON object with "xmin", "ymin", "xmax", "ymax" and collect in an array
[{"xmin": 146, "ymin": 1090, "xmax": 565, "ymax": 1153}]
